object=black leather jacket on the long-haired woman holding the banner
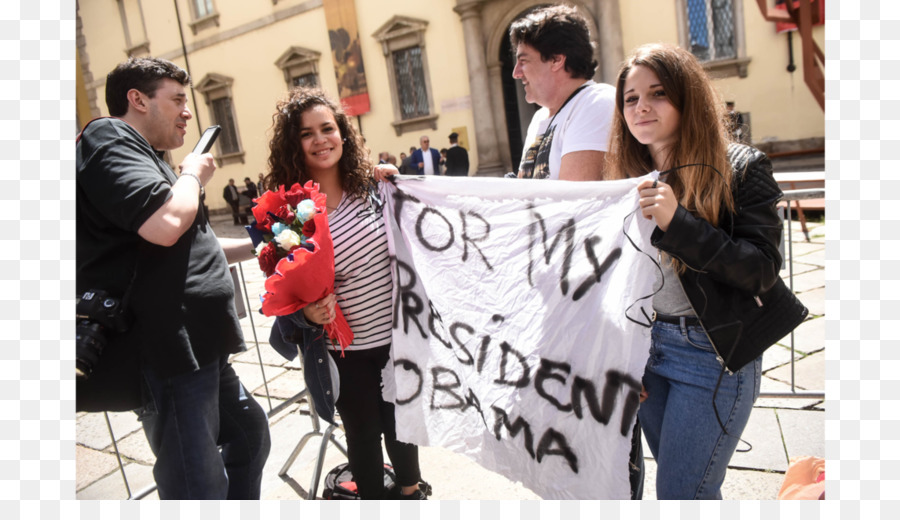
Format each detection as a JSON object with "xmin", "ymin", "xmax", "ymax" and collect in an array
[{"xmin": 650, "ymin": 144, "xmax": 809, "ymax": 372}]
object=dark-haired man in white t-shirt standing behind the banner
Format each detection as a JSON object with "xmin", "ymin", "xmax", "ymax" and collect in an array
[{"xmin": 509, "ymin": 5, "xmax": 616, "ymax": 181}]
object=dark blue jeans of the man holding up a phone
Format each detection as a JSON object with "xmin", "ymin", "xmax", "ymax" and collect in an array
[{"xmin": 136, "ymin": 356, "xmax": 271, "ymax": 500}]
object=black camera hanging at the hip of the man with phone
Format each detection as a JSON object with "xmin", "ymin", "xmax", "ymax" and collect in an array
[{"xmin": 75, "ymin": 290, "xmax": 129, "ymax": 379}]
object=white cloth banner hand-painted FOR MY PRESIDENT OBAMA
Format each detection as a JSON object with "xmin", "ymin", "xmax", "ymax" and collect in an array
[{"xmin": 384, "ymin": 172, "xmax": 657, "ymax": 499}]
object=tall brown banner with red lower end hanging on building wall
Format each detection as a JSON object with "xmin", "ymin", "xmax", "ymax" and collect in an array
[{"xmin": 322, "ymin": 0, "xmax": 369, "ymax": 116}]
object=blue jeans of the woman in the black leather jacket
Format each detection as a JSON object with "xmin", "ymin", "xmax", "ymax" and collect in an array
[{"xmin": 638, "ymin": 320, "xmax": 762, "ymax": 500}]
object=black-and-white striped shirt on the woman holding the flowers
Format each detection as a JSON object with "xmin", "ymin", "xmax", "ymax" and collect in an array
[{"xmin": 328, "ymin": 189, "xmax": 393, "ymax": 350}]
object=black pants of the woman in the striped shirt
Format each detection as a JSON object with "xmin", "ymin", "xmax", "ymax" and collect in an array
[{"xmin": 330, "ymin": 345, "xmax": 422, "ymax": 500}]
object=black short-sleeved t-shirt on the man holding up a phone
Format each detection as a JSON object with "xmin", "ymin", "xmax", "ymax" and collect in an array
[{"xmin": 75, "ymin": 118, "xmax": 245, "ymax": 377}]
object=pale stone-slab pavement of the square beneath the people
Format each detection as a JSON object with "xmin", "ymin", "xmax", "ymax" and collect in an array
[{"xmin": 76, "ymin": 209, "xmax": 826, "ymax": 500}]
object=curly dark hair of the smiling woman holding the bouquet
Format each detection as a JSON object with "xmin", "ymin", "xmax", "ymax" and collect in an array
[{"xmin": 263, "ymin": 87, "xmax": 374, "ymax": 198}]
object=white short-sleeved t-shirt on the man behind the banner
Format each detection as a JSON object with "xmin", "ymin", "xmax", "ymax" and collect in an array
[{"xmin": 519, "ymin": 80, "xmax": 616, "ymax": 179}]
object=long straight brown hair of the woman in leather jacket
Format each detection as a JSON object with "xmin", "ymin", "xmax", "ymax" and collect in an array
[{"xmin": 607, "ymin": 44, "xmax": 734, "ymax": 230}]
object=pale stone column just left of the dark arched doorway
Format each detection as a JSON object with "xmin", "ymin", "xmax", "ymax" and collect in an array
[{"xmin": 453, "ymin": 0, "xmax": 505, "ymax": 176}]
